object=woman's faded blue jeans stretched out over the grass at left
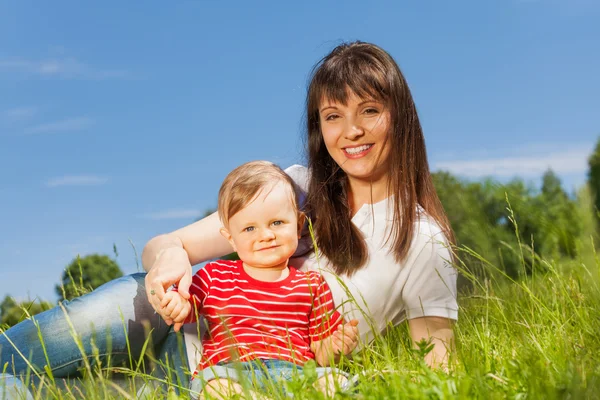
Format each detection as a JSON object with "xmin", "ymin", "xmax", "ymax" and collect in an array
[{"xmin": 0, "ymin": 273, "xmax": 189, "ymax": 392}]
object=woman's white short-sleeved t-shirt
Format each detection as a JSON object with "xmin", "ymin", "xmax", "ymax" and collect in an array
[{"xmin": 184, "ymin": 165, "xmax": 458, "ymax": 369}]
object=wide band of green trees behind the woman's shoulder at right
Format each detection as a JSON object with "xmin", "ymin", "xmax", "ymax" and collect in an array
[{"xmin": 433, "ymin": 170, "xmax": 582, "ymax": 277}]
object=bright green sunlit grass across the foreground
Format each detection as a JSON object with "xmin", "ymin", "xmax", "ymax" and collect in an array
[{"xmin": 0, "ymin": 209, "xmax": 600, "ymax": 399}]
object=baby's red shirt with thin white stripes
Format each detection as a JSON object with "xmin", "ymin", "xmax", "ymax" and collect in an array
[{"xmin": 189, "ymin": 260, "xmax": 343, "ymax": 369}]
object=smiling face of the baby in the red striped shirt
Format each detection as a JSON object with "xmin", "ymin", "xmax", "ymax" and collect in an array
[{"xmin": 221, "ymin": 182, "xmax": 304, "ymax": 268}]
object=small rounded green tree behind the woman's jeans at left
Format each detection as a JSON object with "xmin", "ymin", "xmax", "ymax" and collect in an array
[{"xmin": 56, "ymin": 254, "xmax": 123, "ymax": 300}]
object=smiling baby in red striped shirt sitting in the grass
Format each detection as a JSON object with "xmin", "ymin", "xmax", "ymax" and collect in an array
[{"xmin": 161, "ymin": 161, "xmax": 358, "ymax": 396}]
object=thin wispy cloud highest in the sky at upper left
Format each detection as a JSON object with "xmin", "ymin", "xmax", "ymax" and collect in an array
[{"xmin": 0, "ymin": 57, "xmax": 129, "ymax": 79}]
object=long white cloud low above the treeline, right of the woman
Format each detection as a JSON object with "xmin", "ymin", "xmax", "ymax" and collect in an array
[{"xmin": 434, "ymin": 145, "xmax": 593, "ymax": 177}]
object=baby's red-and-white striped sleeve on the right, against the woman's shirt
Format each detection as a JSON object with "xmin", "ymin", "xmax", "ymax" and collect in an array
[{"xmin": 308, "ymin": 272, "xmax": 344, "ymax": 341}]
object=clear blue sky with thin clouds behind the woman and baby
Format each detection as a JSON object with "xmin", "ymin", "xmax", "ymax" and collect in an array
[{"xmin": 0, "ymin": 0, "xmax": 600, "ymax": 300}]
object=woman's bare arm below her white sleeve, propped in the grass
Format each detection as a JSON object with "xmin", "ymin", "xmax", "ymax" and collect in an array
[{"xmin": 408, "ymin": 317, "xmax": 454, "ymax": 370}]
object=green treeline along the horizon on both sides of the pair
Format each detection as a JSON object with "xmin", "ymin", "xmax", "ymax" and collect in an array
[{"xmin": 0, "ymin": 140, "xmax": 600, "ymax": 328}]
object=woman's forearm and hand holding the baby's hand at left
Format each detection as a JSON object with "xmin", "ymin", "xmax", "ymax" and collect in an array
[{"xmin": 142, "ymin": 213, "xmax": 233, "ymax": 324}]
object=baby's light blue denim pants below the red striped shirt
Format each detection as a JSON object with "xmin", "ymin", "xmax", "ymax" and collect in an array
[{"xmin": 190, "ymin": 359, "xmax": 348, "ymax": 398}]
